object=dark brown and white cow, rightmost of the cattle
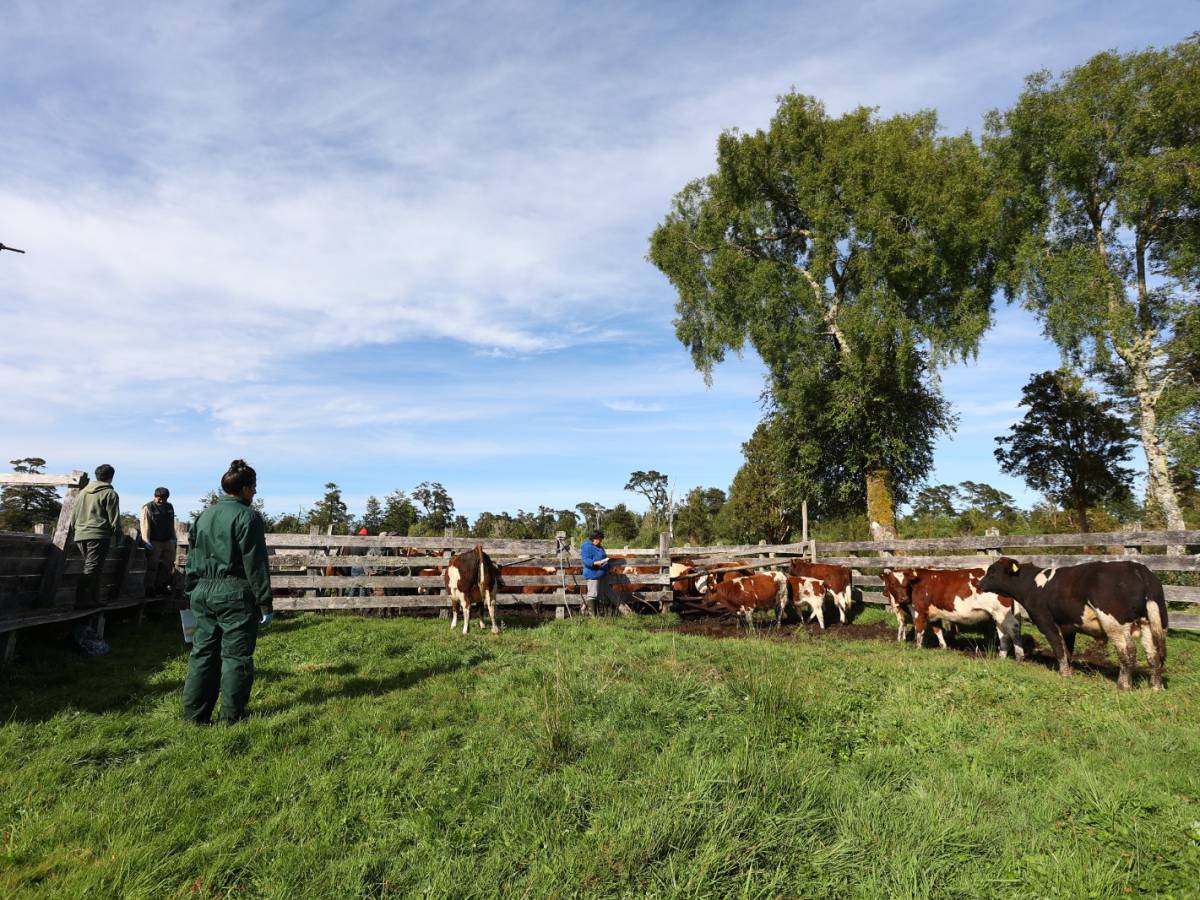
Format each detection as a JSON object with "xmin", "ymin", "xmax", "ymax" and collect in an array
[{"xmin": 980, "ymin": 557, "xmax": 1166, "ymax": 691}]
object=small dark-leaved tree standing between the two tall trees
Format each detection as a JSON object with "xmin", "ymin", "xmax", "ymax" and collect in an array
[{"xmin": 996, "ymin": 371, "xmax": 1134, "ymax": 532}]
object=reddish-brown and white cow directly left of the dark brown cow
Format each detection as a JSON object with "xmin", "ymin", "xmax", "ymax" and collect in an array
[{"xmin": 881, "ymin": 569, "xmax": 1025, "ymax": 660}]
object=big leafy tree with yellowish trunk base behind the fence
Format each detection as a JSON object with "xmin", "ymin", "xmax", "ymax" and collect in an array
[{"xmin": 649, "ymin": 94, "xmax": 997, "ymax": 536}]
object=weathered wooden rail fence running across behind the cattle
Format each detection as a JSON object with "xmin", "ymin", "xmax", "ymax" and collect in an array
[{"xmin": 174, "ymin": 532, "xmax": 1200, "ymax": 628}]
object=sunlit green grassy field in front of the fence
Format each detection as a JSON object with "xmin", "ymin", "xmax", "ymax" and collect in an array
[{"xmin": 0, "ymin": 612, "xmax": 1200, "ymax": 898}]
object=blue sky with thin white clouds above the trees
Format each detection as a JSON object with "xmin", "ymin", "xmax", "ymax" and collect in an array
[{"xmin": 0, "ymin": 0, "xmax": 1200, "ymax": 517}]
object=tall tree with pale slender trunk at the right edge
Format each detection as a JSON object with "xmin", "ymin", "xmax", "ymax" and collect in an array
[{"xmin": 986, "ymin": 40, "xmax": 1200, "ymax": 540}]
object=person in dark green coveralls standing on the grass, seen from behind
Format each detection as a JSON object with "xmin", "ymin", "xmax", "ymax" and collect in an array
[{"xmin": 184, "ymin": 460, "xmax": 274, "ymax": 725}]
